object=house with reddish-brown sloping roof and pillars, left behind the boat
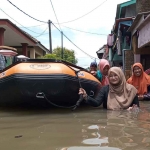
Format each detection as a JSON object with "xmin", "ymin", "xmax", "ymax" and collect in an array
[{"xmin": 0, "ymin": 19, "xmax": 49, "ymax": 59}]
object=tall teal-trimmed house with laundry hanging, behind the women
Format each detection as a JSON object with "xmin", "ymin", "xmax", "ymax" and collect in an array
[{"xmin": 96, "ymin": 0, "xmax": 136, "ymax": 78}]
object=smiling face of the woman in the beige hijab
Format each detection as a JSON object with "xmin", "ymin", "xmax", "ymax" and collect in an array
[{"xmin": 108, "ymin": 72, "xmax": 120, "ymax": 85}]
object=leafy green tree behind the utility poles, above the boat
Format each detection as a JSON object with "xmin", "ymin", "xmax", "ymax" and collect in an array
[{"xmin": 42, "ymin": 47, "xmax": 78, "ymax": 64}]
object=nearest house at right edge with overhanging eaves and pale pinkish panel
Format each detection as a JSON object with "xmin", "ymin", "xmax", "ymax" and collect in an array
[{"xmin": 128, "ymin": 12, "xmax": 150, "ymax": 70}]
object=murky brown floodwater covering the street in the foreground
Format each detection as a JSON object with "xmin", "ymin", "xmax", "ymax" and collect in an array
[{"xmin": 0, "ymin": 101, "xmax": 150, "ymax": 150}]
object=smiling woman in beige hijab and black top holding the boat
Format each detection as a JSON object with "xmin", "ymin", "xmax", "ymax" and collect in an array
[{"xmin": 79, "ymin": 67, "xmax": 139, "ymax": 110}]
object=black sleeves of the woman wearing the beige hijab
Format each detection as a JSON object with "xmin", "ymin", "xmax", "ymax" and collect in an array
[{"xmin": 86, "ymin": 85, "xmax": 139, "ymax": 109}]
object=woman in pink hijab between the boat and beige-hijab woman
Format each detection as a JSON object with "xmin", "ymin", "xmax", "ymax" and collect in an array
[{"xmin": 97, "ymin": 59, "xmax": 110, "ymax": 86}]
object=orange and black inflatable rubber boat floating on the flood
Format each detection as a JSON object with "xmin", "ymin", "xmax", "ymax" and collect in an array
[{"xmin": 0, "ymin": 47, "xmax": 101, "ymax": 106}]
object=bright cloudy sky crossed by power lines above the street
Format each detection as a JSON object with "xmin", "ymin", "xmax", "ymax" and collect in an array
[{"xmin": 0, "ymin": 0, "xmax": 128, "ymax": 68}]
